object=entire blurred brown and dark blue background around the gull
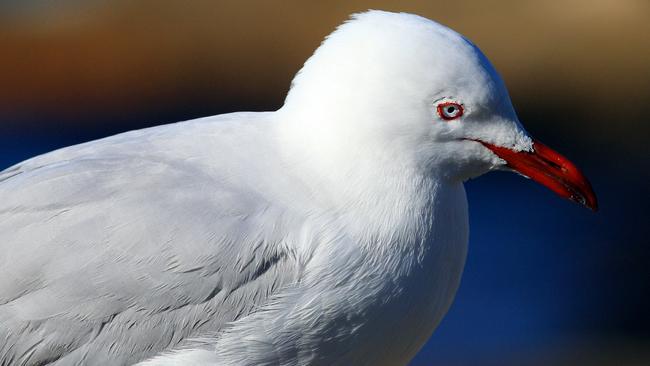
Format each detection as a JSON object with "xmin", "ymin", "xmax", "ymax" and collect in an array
[{"xmin": 0, "ymin": 0, "xmax": 650, "ymax": 366}]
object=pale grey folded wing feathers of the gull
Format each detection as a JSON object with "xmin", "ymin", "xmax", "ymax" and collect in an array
[{"xmin": 0, "ymin": 113, "xmax": 298, "ymax": 365}]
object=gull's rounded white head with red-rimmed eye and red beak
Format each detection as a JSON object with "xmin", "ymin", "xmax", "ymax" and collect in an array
[{"xmin": 281, "ymin": 11, "xmax": 597, "ymax": 210}]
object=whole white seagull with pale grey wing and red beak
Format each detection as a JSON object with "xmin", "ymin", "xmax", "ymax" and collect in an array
[{"xmin": 0, "ymin": 11, "xmax": 597, "ymax": 366}]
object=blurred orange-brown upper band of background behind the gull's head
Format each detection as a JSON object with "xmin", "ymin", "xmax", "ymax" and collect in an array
[{"xmin": 0, "ymin": 0, "xmax": 650, "ymax": 149}]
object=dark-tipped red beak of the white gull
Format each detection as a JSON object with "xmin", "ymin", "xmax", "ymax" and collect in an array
[{"xmin": 479, "ymin": 141, "xmax": 598, "ymax": 211}]
